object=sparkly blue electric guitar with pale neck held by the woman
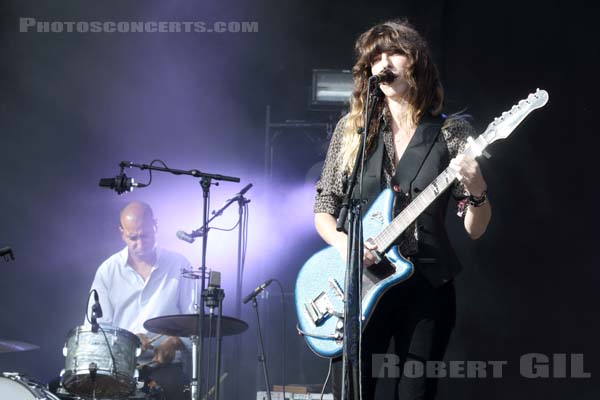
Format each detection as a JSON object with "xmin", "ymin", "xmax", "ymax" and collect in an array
[{"xmin": 295, "ymin": 89, "xmax": 548, "ymax": 357}]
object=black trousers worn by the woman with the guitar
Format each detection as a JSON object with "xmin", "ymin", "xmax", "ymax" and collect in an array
[{"xmin": 332, "ymin": 270, "xmax": 456, "ymax": 400}]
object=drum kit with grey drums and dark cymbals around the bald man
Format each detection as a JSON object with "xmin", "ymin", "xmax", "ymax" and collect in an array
[{"xmin": 0, "ymin": 314, "xmax": 248, "ymax": 400}]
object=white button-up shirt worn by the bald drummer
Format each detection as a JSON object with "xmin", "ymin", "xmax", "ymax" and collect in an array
[{"xmin": 86, "ymin": 247, "xmax": 195, "ymax": 358}]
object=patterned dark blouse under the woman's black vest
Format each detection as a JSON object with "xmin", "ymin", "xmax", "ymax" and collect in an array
[{"xmin": 314, "ymin": 110, "xmax": 475, "ymax": 255}]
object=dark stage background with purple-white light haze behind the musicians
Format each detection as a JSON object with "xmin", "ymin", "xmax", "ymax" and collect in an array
[{"xmin": 0, "ymin": 0, "xmax": 600, "ymax": 399}]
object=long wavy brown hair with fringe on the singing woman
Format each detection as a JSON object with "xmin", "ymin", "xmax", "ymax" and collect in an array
[{"xmin": 341, "ymin": 20, "xmax": 444, "ymax": 172}]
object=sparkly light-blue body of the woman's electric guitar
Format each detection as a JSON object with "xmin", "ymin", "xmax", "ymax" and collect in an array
[{"xmin": 295, "ymin": 189, "xmax": 413, "ymax": 357}]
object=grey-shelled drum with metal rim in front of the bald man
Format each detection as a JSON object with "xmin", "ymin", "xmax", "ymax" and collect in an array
[{"xmin": 61, "ymin": 325, "xmax": 141, "ymax": 398}]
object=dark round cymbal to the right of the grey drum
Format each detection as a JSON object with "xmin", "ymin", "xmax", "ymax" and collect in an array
[{"xmin": 144, "ymin": 314, "xmax": 248, "ymax": 337}]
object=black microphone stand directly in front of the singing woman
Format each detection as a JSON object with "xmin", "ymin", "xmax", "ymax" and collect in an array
[{"xmin": 336, "ymin": 82, "xmax": 381, "ymax": 400}]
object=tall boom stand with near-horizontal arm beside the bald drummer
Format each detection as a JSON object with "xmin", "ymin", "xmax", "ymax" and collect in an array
[{"xmin": 119, "ymin": 161, "xmax": 240, "ymax": 400}]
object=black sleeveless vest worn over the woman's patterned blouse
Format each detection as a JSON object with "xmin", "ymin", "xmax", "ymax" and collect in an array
[{"xmin": 354, "ymin": 116, "xmax": 462, "ymax": 287}]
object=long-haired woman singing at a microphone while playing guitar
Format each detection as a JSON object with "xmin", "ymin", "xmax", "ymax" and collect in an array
[{"xmin": 314, "ymin": 21, "xmax": 491, "ymax": 400}]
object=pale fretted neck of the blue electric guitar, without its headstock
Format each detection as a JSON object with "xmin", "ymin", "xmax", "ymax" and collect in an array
[{"xmin": 373, "ymin": 167, "xmax": 456, "ymax": 250}]
